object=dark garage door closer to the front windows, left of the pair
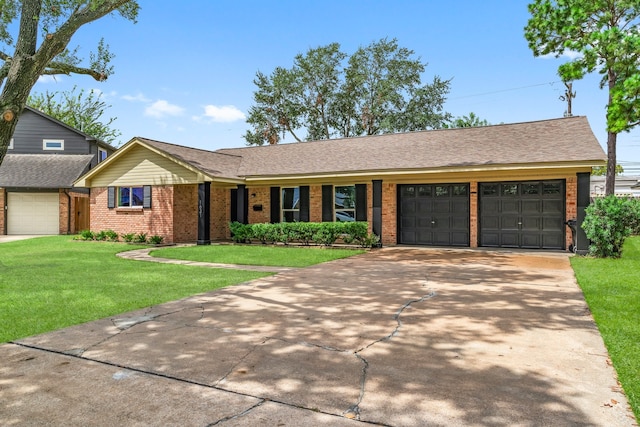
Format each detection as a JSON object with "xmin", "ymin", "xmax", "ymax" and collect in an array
[{"xmin": 398, "ymin": 184, "xmax": 469, "ymax": 246}]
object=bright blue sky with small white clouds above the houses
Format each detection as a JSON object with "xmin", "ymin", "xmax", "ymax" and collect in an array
[{"xmin": 34, "ymin": 0, "xmax": 640, "ymax": 166}]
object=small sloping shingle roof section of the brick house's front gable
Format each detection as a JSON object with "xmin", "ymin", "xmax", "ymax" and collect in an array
[{"xmin": 136, "ymin": 138, "xmax": 242, "ymax": 178}]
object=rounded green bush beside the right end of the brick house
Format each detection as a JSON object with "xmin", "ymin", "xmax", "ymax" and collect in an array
[{"xmin": 582, "ymin": 195, "xmax": 640, "ymax": 258}]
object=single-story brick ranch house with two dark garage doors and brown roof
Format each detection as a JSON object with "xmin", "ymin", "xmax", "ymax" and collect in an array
[{"xmin": 76, "ymin": 117, "xmax": 606, "ymax": 250}]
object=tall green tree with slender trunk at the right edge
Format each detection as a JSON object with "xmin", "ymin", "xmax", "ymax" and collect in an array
[{"xmin": 525, "ymin": 0, "xmax": 640, "ymax": 195}]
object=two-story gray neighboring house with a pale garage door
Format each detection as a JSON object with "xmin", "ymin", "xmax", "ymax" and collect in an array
[{"xmin": 0, "ymin": 107, "xmax": 116, "ymax": 234}]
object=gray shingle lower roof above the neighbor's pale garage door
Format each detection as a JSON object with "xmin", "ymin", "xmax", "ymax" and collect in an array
[{"xmin": 0, "ymin": 154, "xmax": 93, "ymax": 188}]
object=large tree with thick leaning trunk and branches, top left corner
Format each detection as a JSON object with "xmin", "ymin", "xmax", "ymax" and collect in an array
[{"xmin": 0, "ymin": 0, "xmax": 139, "ymax": 164}]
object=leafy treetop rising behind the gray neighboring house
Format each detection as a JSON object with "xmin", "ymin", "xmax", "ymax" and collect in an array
[{"xmin": 27, "ymin": 86, "xmax": 122, "ymax": 144}]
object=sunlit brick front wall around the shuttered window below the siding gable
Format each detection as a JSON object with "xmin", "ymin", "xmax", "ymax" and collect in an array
[{"xmin": 89, "ymin": 185, "xmax": 174, "ymax": 243}]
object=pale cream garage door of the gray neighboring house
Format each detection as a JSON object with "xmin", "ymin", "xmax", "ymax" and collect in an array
[{"xmin": 7, "ymin": 193, "xmax": 60, "ymax": 234}]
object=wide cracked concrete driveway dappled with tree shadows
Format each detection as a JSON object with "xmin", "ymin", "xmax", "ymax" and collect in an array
[{"xmin": 0, "ymin": 248, "xmax": 635, "ymax": 426}]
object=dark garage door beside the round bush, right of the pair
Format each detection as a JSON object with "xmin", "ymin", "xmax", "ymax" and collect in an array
[{"xmin": 479, "ymin": 180, "xmax": 565, "ymax": 249}]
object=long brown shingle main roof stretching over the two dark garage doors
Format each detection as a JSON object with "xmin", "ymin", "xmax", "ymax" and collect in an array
[{"xmin": 217, "ymin": 116, "xmax": 606, "ymax": 176}]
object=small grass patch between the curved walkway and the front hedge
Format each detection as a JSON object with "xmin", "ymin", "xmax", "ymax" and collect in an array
[{"xmin": 151, "ymin": 244, "xmax": 364, "ymax": 267}]
